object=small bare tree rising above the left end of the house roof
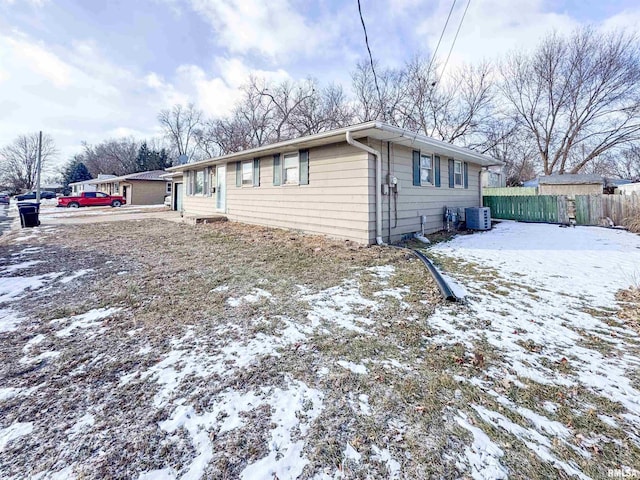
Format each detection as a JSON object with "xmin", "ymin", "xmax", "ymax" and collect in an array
[{"xmin": 158, "ymin": 103, "xmax": 203, "ymax": 161}]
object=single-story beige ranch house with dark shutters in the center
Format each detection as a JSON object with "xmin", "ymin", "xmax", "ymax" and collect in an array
[{"xmin": 168, "ymin": 122, "xmax": 502, "ymax": 244}]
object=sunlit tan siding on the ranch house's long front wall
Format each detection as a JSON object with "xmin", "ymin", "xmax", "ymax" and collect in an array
[{"xmin": 225, "ymin": 142, "xmax": 370, "ymax": 243}]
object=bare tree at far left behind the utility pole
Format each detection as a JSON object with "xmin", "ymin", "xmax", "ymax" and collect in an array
[{"xmin": 0, "ymin": 132, "xmax": 57, "ymax": 190}]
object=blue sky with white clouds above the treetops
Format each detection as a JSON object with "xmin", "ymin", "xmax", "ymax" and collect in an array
[{"xmin": 0, "ymin": 0, "xmax": 640, "ymax": 169}]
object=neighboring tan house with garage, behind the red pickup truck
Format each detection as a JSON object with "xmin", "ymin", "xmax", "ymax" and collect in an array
[{"xmin": 92, "ymin": 170, "xmax": 172, "ymax": 205}]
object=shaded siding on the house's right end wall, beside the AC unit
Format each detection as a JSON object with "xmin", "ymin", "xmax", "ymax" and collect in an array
[{"xmin": 369, "ymin": 140, "xmax": 480, "ymax": 243}]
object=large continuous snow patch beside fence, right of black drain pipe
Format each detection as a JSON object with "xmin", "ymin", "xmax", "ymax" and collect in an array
[{"xmin": 429, "ymin": 222, "xmax": 640, "ymax": 412}]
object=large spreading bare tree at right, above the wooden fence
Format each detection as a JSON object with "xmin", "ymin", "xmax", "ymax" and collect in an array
[{"xmin": 501, "ymin": 28, "xmax": 640, "ymax": 175}]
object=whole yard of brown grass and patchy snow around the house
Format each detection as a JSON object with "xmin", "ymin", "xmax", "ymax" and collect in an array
[{"xmin": 0, "ymin": 221, "xmax": 640, "ymax": 480}]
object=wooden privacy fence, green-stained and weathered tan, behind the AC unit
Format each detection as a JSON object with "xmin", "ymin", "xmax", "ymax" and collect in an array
[{"xmin": 482, "ymin": 193, "xmax": 640, "ymax": 225}]
